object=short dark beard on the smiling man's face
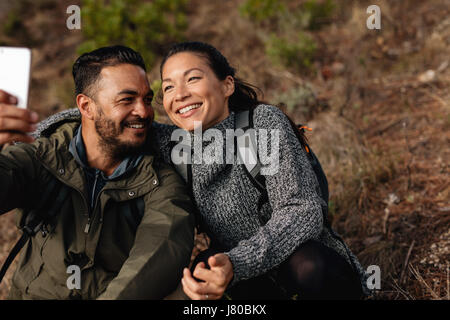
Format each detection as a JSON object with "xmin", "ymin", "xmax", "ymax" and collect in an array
[{"xmin": 94, "ymin": 110, "xmax": 150, "ymax": 160}]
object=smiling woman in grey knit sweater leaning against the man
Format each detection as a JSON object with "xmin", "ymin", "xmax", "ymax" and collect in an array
[{"xmin": 29, "ymin": 42, "xmax": 368, "ymax": 300}]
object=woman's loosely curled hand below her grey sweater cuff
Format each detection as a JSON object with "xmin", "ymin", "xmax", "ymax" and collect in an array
[{"xmin": 181, "ymin": 253, "xmax": 233, "ymax": 300}]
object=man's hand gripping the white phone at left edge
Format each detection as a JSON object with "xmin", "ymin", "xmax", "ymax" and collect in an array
[{"xmin": 0, "ymin": 90, "xmax": 39, "ymax": 148}]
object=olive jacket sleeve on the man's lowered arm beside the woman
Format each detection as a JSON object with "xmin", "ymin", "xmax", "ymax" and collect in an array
[{"xmin": 99, "ymin": 166, "xmax": 194, "ymax": 299}]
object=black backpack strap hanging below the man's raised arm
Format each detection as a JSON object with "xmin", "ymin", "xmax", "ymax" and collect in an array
[{"xmin": 0, "ymin": 178, "xmax": 70, "ymax": 283}]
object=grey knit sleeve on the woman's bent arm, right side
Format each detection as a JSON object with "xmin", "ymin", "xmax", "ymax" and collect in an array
[{"xmin": 226, "ymin": 105, "xmax": 323, "ymax": 285}]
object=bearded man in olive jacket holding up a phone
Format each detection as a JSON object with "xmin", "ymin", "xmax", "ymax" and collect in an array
[{"xmin": 0, "ymin": 46, "xmax": 194, "ymax": 299}]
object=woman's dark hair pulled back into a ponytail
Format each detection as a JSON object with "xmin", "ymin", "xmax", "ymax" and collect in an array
[{"xmin": 159, "ymin": 41, "xmax": 307, "ymax": 146}]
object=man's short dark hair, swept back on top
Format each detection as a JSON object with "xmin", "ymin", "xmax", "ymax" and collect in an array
[{"xmin": 72, "ymin": 46, "xmax": 147, "ymax": 95}]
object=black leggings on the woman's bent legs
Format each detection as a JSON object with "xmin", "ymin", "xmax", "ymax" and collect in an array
[{"xmin": 191, "ymin": 240, "xmax": 362, "ymax": 300}]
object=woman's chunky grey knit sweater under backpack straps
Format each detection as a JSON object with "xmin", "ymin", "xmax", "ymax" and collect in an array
[{"xmin": 36, "ymin": 105, "xmax": 368, "ymax": 294}]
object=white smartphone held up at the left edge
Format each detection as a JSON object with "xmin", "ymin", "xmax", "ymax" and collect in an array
[{"xmin": 0, "ymin": 47, "xmax": 31, "ymax": 108}]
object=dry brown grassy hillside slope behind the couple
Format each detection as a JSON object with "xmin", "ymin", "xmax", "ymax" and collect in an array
[{"xmin": 0, "ymin": 0, "xmax": 450, "ymax": 299}]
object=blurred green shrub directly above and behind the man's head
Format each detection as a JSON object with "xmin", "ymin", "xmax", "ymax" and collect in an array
[{"xmin": 78, "ymin": 0, "xmax": 187, "ymax": 65}]
